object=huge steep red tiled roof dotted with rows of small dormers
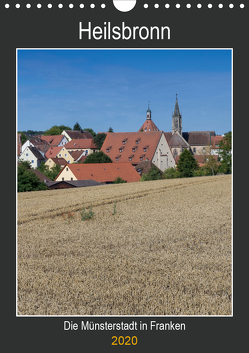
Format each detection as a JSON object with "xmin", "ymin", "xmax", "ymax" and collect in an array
[{"xmin": 101, "ymin": 131, "xmax": 162, "ymax": 164}]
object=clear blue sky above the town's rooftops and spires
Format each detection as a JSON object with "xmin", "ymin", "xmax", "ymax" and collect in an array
[{"xmin": 17, "ymin": 49, "xmax": 232, "ymax": 134}]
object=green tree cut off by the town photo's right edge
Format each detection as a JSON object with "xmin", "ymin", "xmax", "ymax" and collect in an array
[{"xmin": 218, "ymin": 131, "xmax": 232, "ymax": 174}]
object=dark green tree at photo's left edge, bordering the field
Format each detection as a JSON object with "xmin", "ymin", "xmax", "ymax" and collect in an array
[{"xmin": 17, "ymin": 161, "xmax": 48, "ymax": 192}]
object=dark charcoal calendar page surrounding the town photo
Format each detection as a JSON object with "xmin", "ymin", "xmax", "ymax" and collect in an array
[{"xmin": 0, "ymin": 0, "xmax": 245, "ymax": 352}]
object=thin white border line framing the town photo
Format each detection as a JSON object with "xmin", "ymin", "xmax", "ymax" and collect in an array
[{"xmin": 16, "ymin": 48, "xmax": 234, "ymax": 316}]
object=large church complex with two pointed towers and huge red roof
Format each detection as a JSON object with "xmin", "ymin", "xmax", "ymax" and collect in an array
[{"xmin": 101, "ymin": 95, "xmax": 218, "ymax": 172}]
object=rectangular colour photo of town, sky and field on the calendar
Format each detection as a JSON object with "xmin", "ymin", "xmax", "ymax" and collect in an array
[{"xmin": 16, "ymin": 49, "xmax": 233, "ymax": 316}]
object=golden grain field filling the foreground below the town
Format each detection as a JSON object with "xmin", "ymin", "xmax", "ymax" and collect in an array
[{"xmin": 17, "ymin": 175, "xmax": 232, "ymax": 315}]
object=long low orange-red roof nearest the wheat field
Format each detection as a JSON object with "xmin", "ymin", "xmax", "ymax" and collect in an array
[{"xmin": 57, "ymin": 163, "xmax": 141, "ymax": 183}]
